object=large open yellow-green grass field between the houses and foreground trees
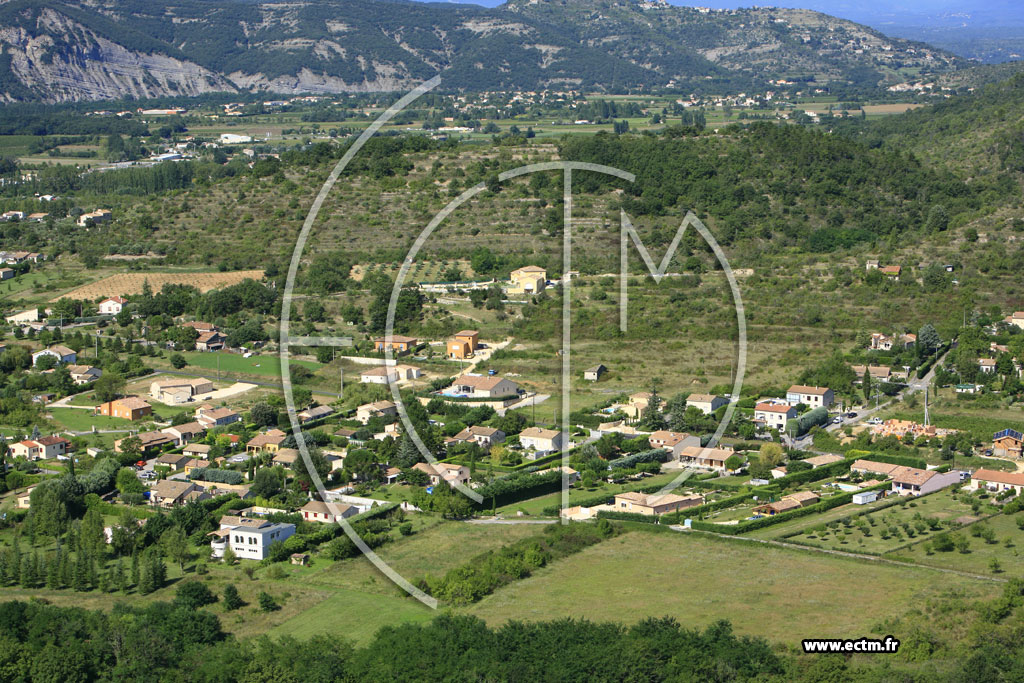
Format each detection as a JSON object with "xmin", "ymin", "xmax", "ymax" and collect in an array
[{"xmin": 469, "ymin": 531, "xmax": 1000, "ymax": 644}]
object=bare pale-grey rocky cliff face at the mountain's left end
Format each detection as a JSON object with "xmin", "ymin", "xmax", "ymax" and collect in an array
[{"xmin": 0, "ymin": 8, "xmax": 236, "ymax": 102}]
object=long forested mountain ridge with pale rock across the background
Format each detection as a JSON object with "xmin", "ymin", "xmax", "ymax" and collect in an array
[{"xmin": 0, "ymin": 0, "xmax": 962, "ymax": 102}]
